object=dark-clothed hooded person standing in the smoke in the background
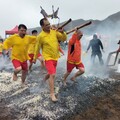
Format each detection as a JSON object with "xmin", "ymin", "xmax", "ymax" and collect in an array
[{"xmin": 86, "ymin": 34, "xmax": 104, "ymax": 65}]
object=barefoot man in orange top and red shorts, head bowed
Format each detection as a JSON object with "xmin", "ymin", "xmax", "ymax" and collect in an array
[{"xmin": 62, "ymin": 29, "xmax": 85, "ymax": 86}]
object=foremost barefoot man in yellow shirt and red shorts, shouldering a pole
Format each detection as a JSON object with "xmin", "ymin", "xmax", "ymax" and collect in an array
[{"xmin": 34, "ymin": 18, "xmax": 67, "ymax": 102}]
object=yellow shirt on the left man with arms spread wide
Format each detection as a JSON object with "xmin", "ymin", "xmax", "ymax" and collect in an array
[{"xmin": 3, "ymin": 34, "xmax": 36, "ymax": 62}]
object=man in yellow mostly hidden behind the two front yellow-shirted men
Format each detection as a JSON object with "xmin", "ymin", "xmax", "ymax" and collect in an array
[{"xmin": 28, "ymin": 30, "xmax": 44, "ymax": 70}]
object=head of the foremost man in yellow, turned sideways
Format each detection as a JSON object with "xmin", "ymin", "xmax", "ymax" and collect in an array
[{"xmin": 40, "ymin": 18, "xmax": 51, "ymax": 32}]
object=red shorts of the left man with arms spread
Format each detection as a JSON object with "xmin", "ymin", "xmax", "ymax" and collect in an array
[{"xmin": 12, "ymin": 59, "xmax": 28, "ymax": 70}]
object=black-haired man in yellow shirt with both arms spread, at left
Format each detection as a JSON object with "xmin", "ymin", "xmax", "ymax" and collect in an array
[{"xmin": 3, "ymin": 24, "xmax": 36, "ymax": 84}]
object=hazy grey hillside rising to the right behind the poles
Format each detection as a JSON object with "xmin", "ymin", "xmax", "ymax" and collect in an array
[{"xmin": 30, "ymin": 12, "xmax": 120, "ymax": 36}]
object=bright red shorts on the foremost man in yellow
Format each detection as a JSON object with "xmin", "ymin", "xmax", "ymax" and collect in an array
[{"xmin": 45, "ymin": 60, "xmax": 57, "ymax": 75}]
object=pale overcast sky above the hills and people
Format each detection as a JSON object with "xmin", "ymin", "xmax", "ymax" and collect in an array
[{"xmin": 0, "ymin": 0, "xmax": 120, "ymax": 38}]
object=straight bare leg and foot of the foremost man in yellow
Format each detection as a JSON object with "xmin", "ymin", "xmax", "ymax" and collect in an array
[{"xmin": 49, "ymin": 75, "xmax": 57, "ymax": 102}]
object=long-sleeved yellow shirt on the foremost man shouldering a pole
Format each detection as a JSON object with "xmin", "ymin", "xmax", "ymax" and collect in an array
[{"xmin": 34, "ymin": 30, "xmax": 67, "ymax": 60}]
